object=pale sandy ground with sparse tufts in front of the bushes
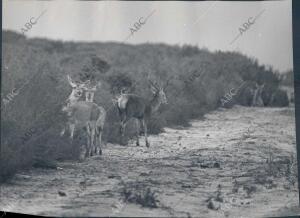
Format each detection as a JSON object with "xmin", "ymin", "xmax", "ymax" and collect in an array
[{"xmin": 0, "ymin": 106, "xmax": 300, "ymax": 217}]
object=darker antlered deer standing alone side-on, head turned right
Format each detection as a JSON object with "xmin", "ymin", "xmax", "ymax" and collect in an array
[{"xmin": 116, "ymin": 76, "xmax": 169, "ymax": 147}]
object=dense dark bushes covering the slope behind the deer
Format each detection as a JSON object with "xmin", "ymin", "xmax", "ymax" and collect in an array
[{"xmin": 0, "ymin": 31, "xmax": 287, "ymax": 180}]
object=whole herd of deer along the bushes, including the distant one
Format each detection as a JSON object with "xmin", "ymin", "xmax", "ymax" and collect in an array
[{"xmin": 61, "ymin": 75, "xmax": 263, "ymax": 159}]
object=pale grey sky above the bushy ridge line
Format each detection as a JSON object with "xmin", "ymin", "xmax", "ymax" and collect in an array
[{"xmin": 2, "ymin": 0, "xmax": 293, "ymax": 71}]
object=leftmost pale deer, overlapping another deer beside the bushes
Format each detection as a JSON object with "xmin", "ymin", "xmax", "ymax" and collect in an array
[{"xmin": 61, "ymin": 75, "xmax": 106, "ymax": 158}]
